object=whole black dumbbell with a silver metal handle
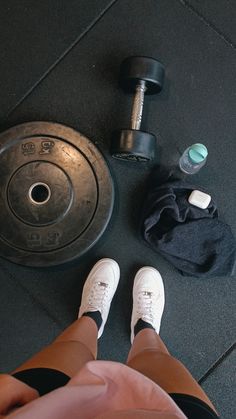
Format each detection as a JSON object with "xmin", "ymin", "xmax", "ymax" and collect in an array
[{"xmin": 111, "ymin": 57, "xmax": 165, "ymax": 161}]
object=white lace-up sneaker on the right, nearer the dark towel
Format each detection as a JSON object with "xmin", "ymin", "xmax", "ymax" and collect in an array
[{"xmin": 131, "ymin": 266, "xmax": 165, "ymax": 343}]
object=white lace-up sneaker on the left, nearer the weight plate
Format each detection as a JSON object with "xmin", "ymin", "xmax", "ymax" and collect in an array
[{"xmin": 78, "ymin": 258, "xmax": 120, "ymax": 338}]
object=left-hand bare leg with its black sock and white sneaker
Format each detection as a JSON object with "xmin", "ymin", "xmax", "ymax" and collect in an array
[{"xmin": 12, "ymin": 259, "xmax": 120, "ymax": 377}]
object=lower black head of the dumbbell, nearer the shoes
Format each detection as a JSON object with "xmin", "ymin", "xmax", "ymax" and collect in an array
[{"xmin": 111, "ymin": 129, "xmax": 156, "ymax": 161}]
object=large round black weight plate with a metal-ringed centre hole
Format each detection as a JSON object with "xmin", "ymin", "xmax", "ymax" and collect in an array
[{"xmin": 0, "ymin": 122, "xmax": 114, "ymax": 267}]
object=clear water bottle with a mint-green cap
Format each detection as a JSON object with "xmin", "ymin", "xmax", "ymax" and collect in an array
[{"xmin": 179, "ymin": 143, "xmax": 208, "ymax": 175}]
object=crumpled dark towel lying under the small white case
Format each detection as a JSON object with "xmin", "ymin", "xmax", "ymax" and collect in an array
[{"xmin": 142, "ymin": 169, "xmax": 236, "ymax": 278}]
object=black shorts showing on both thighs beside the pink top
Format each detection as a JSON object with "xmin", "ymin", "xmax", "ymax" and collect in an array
[{"xmin": 13, "ymin": 368, "xmax": 219, "ymax": 419}]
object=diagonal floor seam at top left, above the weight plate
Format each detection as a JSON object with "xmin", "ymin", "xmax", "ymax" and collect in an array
[{"xmin": 6, "ymin": 0, "xmax": 118, "ymax": 119}]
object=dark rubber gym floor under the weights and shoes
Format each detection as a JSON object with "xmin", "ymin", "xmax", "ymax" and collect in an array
[{"xmin": 0, "ymin": 0, "xmax": 236, "ymax": 419}]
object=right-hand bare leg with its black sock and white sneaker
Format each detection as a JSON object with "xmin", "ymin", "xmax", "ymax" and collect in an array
[{"xmin": 127, "ymin": 267, "xmax": 215, "ymax": 411}]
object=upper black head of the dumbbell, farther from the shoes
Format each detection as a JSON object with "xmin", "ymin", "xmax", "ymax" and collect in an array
[{"xmin": 120, "ymin": 57, "xmax": 165, "ymax": 95}]
